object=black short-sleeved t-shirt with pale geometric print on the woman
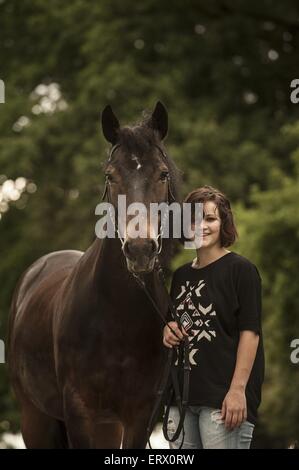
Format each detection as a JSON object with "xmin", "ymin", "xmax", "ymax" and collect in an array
[{"xmin": 171, "ymin": 252, "xmax": 264, "ymax": 424}]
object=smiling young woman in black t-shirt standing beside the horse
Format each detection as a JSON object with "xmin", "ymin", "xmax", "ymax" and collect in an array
[{"xmin": 163, "ymin": 186, "xmax": 264, "ymax": 449}]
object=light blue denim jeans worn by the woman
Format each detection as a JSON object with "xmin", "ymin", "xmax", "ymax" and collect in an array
[{"xmin": 167, "ymin": 406, "xmax": 254, "ymax": 449}]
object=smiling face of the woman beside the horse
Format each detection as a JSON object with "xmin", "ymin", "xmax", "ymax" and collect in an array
[{"xmin": 192, "ymin": 201, "xmax": 221, "ymax": 248}]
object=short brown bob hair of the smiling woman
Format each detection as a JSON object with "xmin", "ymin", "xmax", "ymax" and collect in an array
[{"xmin": 184, "ymin": 185, "xmax": 238, "ymax": 248}]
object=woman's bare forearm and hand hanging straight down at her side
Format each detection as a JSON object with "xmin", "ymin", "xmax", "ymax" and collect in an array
[{"xmin": 221, "ymin": 330, "xmax": 259, "ymax": 429}]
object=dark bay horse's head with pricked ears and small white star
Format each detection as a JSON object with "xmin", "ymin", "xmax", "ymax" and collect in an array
[{"xmin": 102, "ymin": 102, "xmax": 177, "ymax": 274}]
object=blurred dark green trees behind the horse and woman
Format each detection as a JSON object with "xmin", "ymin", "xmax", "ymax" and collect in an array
[{"xmin": 0, "ymin": 0, "xmax": 299, "ymax": 448}]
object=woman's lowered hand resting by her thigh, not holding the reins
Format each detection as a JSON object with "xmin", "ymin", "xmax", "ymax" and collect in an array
[{"xmin": 221, "ymin": 388, "xmax": 247, "ymax": 429}]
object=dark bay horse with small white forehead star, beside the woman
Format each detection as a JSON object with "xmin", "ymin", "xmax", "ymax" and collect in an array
[{"xmin": 9, "ymin": 102, "xmax": 178, "ymax": 448}]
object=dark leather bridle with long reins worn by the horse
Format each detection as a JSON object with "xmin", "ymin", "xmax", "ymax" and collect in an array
[{"xmin": 101, "ymin": 143, "xmax": 191, "ymax": 449}]
